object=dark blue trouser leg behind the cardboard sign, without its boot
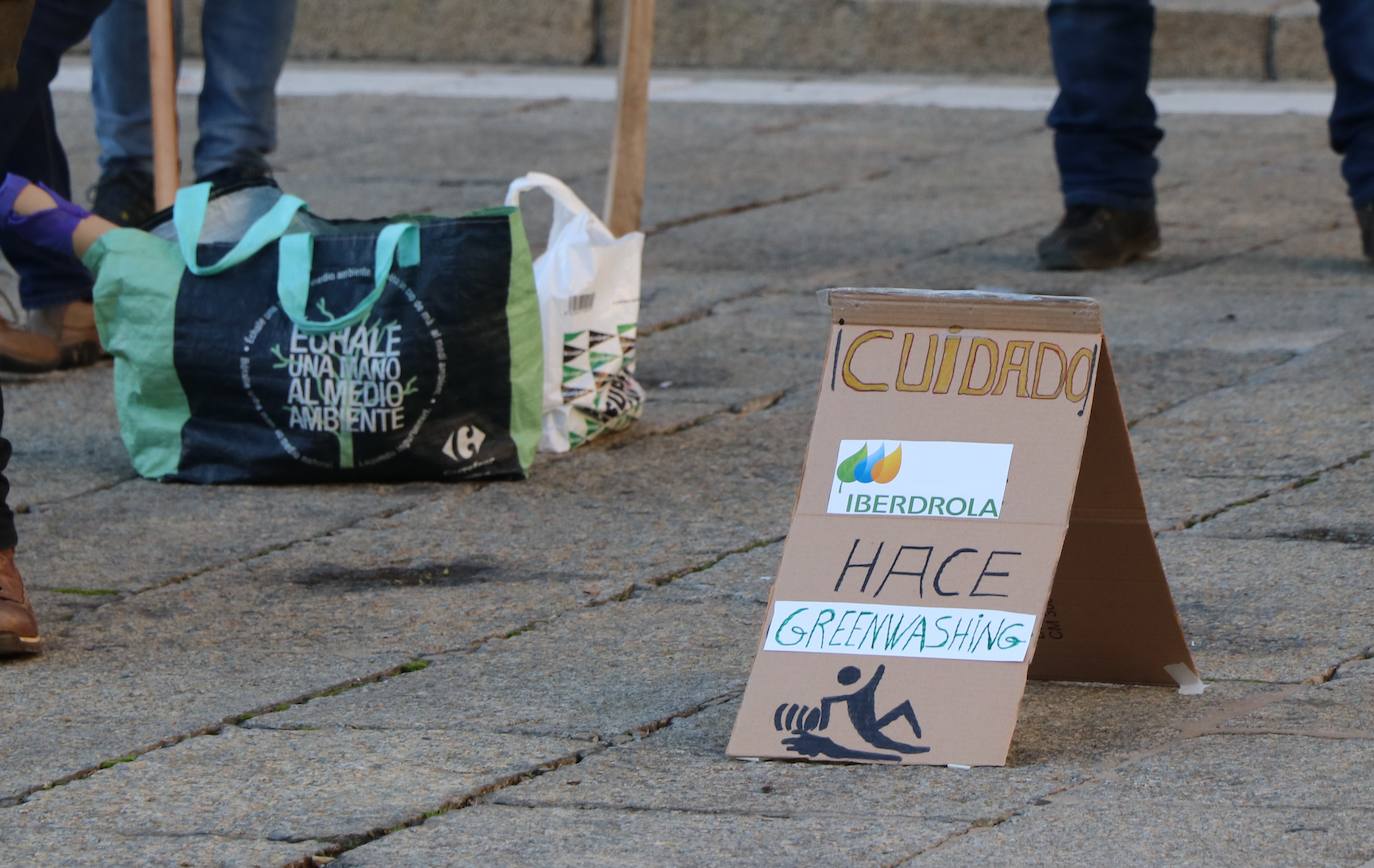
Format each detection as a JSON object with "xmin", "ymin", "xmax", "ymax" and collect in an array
[{"xmin": 1047, "ymin": 0, "xmax": 1159, "ymax": 209}]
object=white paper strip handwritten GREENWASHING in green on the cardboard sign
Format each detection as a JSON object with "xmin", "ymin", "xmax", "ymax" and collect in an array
[{"xmin": 764, "ymin": 600, "xmax": 1036, "ymax": 663}]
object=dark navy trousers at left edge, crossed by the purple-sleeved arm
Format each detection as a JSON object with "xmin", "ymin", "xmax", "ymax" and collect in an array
[{"xmin": 0, "ymin": 0, "xmax": 110, "ymax": 309}]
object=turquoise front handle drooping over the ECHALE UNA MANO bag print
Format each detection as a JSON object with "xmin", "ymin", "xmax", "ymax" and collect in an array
[{"xmin": 276, "ymin": 222, "xmax": 420, "ymax": 335}]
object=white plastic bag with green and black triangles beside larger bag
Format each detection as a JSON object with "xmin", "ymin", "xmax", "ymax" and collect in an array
[{"xmin": 506, "ymin": 172, "xmax": 644, "ymax": 452}]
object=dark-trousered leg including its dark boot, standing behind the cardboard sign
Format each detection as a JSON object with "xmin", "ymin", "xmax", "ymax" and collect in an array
[{"xmin": 1040, "ymin": 0, "xmax": 1164, "ymax": 268}]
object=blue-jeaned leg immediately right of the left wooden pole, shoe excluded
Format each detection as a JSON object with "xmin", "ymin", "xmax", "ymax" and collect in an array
[{"xmin": 195, "ymin": 0, "xmax": 295, "ymax": 179}]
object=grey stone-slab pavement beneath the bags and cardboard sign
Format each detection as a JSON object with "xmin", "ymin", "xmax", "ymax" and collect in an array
[{"xmin": 0, "ymin": 69, "xmax": 1374, "ymax": 865}]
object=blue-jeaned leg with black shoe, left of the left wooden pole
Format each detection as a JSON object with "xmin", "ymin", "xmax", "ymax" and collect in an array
[{"xmin": 91, "ymin": 0, "xmax": 181, "ymax": 225}]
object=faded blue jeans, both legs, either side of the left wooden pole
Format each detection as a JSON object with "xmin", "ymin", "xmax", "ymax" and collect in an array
[{"xmin": 91, "ymin": 0, "xmax": 295, "ymax": 177}]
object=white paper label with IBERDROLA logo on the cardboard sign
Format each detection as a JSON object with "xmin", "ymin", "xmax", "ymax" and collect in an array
[{"xmin": 826, "ymin": 439, "xmax": 1011, "ymax": 519}]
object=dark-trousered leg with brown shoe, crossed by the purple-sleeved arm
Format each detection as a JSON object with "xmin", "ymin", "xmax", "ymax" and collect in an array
[{"xmin": 0, "ymin": 0, "xmax": 109, "ymax": 371}]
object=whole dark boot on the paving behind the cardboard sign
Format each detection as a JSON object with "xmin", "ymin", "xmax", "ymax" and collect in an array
[{"xmin": 1036, "ymin": 205, "xmax": 1160, "ymax": 271}]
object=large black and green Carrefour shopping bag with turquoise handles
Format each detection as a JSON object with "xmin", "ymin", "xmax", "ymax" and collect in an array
[{"xmin": 84, "ymin": 184, "xmax": 543, "ymax": 482}]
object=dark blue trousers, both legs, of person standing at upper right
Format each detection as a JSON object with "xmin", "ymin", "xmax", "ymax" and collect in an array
[{"xmin": 1047, "ymin": 0, "xmax": 1374, "ymax": 209}]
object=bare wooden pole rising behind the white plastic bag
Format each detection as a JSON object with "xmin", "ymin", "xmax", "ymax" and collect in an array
[{"xmin": 606, "ymin": 0, "xmax": 654, "ymax": 235}]
